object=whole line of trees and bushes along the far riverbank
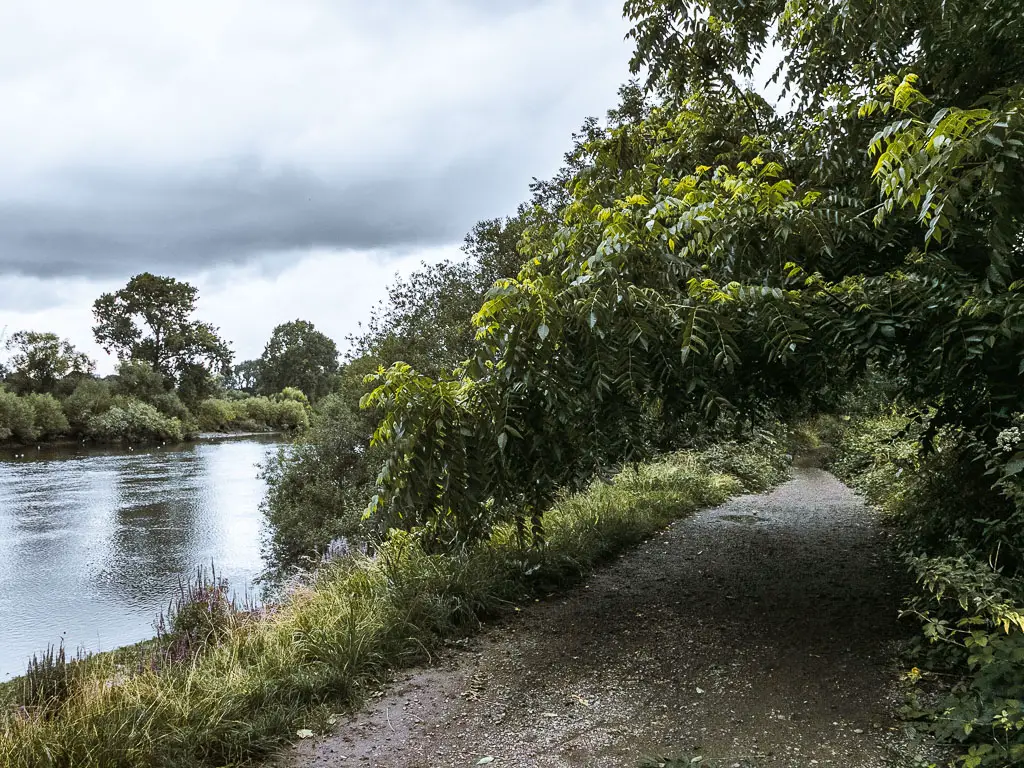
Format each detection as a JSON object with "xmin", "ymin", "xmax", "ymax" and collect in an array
[{"xmin": 0, "ymin": 272, "xmax": 350, "ymax": 444}]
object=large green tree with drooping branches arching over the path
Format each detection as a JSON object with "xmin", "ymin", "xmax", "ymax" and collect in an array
[{"xmin": 367, "ymin": 0, "xmax": 1024, "ymax": 552}]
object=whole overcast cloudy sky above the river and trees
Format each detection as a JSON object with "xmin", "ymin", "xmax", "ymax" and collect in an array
[{"xmin": 0, "ymin": 0, "xmax": 631, "ymax": 373}]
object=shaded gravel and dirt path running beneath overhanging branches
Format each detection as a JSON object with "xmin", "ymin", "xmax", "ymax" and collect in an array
[{"xmin": 282, "ymin": 468, "xmax": 913, "ymax": 768}]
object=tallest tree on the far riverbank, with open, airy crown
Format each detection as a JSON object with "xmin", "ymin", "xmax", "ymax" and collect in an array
[{"xmin": 92, "ymin": 272, "xmax": 231, "ymax": 391}]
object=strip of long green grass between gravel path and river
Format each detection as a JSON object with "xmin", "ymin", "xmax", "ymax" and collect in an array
[{"xmin": 0, "ymin": 441, "xmax": 785, "ymax": 768}]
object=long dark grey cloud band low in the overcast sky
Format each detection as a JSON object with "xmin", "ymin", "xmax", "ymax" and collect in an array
[{"xmin": 0, "ymin": 163, "xmax": 513, "ymax": 278}]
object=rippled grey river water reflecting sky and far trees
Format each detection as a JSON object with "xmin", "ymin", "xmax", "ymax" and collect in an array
[{"xmin": 0, "ymin": 436, "xmax": 279, "ymax": 681}]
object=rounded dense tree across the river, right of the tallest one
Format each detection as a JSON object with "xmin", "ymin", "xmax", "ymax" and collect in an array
[{"xmin": 257, "ymin": 319, "xmax": 338, "ymax": 401}]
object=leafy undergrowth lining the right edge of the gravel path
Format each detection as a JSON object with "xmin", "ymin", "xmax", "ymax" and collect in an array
[{"xmin": 825, "ymin": 415, "xmax": 1024, "ymax": 768}]
